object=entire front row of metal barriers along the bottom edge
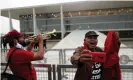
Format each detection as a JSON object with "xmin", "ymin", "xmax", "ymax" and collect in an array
[{"xmin": 1, "ymin": 63, "xmax": 133, "ymax": 80}]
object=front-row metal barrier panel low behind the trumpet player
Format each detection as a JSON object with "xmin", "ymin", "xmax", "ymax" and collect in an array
[{"xmin": 1, "ymin": 63, "xmax": 52, "ymax": 80}]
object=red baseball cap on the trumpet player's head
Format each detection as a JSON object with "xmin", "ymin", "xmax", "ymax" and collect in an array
[{"xmin": 4, "ymin": 29, "xmax": 24, "ymax": 41}]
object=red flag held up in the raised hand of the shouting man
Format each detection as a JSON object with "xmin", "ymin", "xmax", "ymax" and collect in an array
[{"xmin": 104, "ymin": 31, "xmax": 120, "ymax": 68}]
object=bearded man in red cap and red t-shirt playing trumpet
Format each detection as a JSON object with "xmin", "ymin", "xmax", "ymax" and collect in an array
[{"xmin": 5, "ymin": 30, "xmax": 44, "ymax": 80}]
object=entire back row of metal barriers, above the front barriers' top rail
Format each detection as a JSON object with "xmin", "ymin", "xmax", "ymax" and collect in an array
[{"xmin": 0, "ymin": 47, "xmax": 133, "ymax": 64}]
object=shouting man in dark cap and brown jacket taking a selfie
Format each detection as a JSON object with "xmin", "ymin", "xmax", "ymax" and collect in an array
[{"xmin": 71, "ymin": 31, "xmax": 121, "ymax": 80}]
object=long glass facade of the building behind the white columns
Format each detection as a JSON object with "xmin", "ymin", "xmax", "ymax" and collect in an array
[{"xmin": 20, "ymin": 8, "xmax": 133, "ymax": 33}]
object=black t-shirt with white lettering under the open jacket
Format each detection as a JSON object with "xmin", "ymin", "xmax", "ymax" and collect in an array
[{"xmin": 91, "ymin": 62, "xmax": 102, "ymax": 80}]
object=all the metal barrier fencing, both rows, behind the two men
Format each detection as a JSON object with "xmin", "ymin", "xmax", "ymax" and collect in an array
[{"xmin": 0, "ymin": 47, "xmax": 133, "ymax": 80}]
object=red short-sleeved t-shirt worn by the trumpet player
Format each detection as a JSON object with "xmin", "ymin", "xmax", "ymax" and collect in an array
[{"xmin": 7, "ymin": 48, "xmax": 37, "ymax": 80}]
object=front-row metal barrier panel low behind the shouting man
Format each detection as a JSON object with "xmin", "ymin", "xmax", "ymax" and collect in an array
[{"xmin": 57, "ymin": 65, "xmax": 133, "ymax": 80}]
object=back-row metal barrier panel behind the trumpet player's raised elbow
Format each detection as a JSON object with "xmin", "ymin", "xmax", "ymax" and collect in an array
[{"xmin": 0, "ymin": 49, "xmax": 63, "ymax": 64}]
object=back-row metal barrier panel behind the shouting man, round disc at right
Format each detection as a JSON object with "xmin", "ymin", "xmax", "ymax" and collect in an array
[{"xmin": 62, "ymin": 47, "xmax": 133, "ymax": 65}]
